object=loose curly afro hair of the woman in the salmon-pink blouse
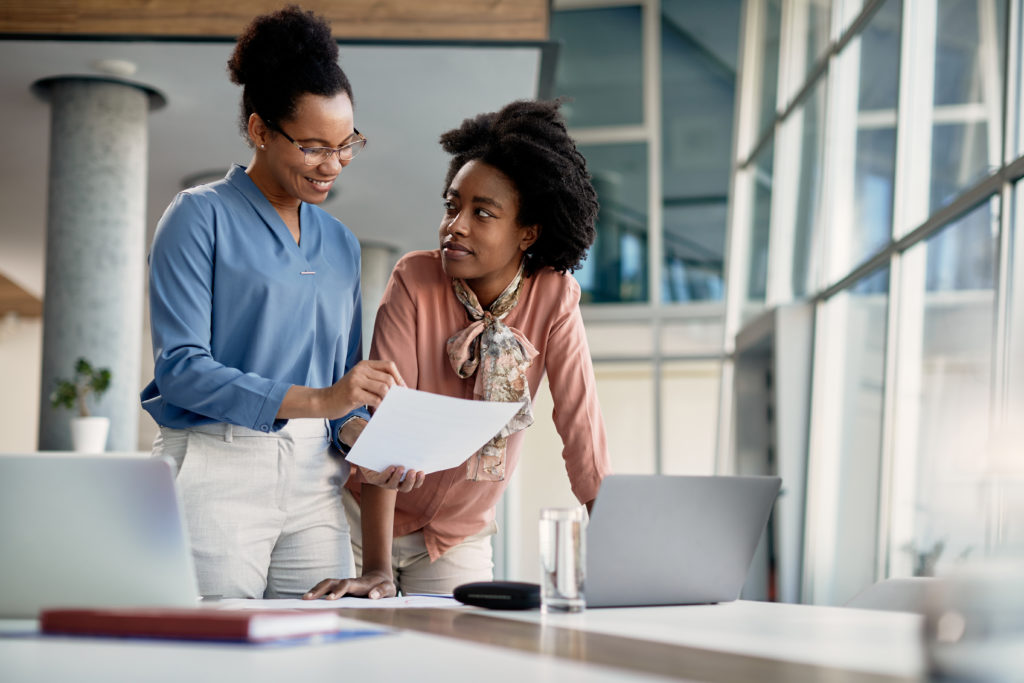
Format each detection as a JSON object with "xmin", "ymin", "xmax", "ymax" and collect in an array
[{"xmin": 441, "ymin": 100, "xmax": 598, "ymax": 275}]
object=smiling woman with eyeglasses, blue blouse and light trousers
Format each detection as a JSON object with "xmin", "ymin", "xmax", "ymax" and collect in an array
[{"xmin": 141, "ymin": 6, "xmax": 417, "ymax": 598}]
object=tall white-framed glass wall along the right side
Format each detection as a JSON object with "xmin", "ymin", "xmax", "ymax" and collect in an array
[{"xmin": 718, "ymin": 0, "xmax": 1024, "ymax": 604}]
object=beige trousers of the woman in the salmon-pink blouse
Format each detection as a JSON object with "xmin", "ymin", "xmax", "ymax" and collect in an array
[{"xmin": 341, "ymin": 488, "xmax": 498, "ymax": 595}]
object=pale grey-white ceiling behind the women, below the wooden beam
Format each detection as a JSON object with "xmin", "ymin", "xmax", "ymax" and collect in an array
[{"xmin": 0, "ymin": 40, "xmax": 542, "ymax": 296}]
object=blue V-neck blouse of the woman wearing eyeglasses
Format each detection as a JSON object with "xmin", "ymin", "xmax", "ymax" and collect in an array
[{"xmin": 141, "ymin": 166, "xmax": 366, "ymax": 438}]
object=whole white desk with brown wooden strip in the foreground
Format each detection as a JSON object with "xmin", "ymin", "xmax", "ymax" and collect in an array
[{"xmin": 0, "ymin": 601, "xmax": 924, "ymax": 683}]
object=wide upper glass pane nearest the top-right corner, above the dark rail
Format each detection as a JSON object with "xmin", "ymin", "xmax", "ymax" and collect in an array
[{"xmin": 930, "ymin": 0, "xmax": 1007, "ymax": 211}]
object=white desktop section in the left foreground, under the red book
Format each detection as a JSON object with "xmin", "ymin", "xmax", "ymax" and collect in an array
[{"xmin": 0, "ymin": 632, "xmax": 664, "ymax": 683}]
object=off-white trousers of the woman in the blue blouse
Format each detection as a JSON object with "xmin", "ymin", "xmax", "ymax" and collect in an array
[{"xmin": 153, "ymin": 419, "xmax": 354, "ymax": 598}]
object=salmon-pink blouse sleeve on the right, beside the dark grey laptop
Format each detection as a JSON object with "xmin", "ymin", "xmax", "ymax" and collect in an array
[{"xmin": 545, "ymin": 278, "xmax": 611, "ymax": 503}]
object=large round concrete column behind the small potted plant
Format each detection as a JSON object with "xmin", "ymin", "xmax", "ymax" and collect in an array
[{"xmin": 33, "ymin": 77, "xmax": 164, "ymax": 451}]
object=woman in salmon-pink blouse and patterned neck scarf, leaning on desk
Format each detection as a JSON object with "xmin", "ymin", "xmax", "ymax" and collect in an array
[{"xmin": 309, "ymin": 101, "xmax": 609, "ymax": 597}]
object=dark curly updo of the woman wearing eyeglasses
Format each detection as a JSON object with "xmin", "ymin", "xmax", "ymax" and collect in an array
[{"xmin": 227, "ymin": 5, "xmax": 352, "ymax": 144}]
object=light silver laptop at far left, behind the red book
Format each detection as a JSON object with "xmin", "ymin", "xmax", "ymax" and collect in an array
[{"xmin": 0, "ymin": 454, "xmax": 199, "ymax": 618}]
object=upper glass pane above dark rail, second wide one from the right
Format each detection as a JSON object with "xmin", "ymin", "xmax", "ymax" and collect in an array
[{"xmin": 827, "ymin": 0, "xmax": 902, "ymax": 282}]
